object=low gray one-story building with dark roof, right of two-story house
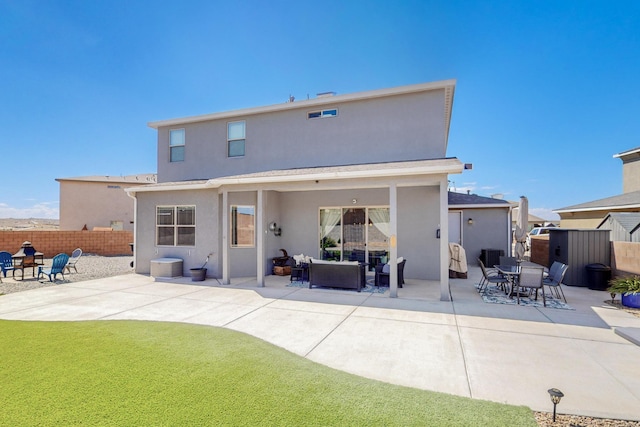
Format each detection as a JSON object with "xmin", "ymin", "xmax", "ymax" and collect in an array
[{"xmin": 449, "ymin": 192, "xmax": 515, "ymax": 265}]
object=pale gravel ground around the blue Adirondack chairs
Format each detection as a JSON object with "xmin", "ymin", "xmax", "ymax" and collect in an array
[{"xmin": 0, "ymin": 254, "xmax": 133, "ymax": 295}]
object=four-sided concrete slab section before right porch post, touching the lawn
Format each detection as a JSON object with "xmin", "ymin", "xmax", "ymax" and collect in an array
[{"xmin": 308, "ymin": 314, "xmax": 470, "ymax": 396}]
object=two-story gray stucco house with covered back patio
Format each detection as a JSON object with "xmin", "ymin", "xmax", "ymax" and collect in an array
[{"xmin": 127, "ymin": 80, "xmax": 464, "ymax": 300}]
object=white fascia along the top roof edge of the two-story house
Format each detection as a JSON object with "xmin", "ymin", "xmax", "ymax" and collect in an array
[{"xmin": 147, "ymin": 79, "xmax": 456, "ymax": 132}]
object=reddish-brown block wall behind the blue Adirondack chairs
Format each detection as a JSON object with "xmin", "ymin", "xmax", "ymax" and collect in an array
[{"xmin": 0, "ymin": 230, "xmax": 133, "ymax": 258}]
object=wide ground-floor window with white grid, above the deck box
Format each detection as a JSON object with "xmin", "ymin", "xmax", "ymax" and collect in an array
[{"xmin": 156, "ymin": 206, "xmax": 196, "ymax": 246}]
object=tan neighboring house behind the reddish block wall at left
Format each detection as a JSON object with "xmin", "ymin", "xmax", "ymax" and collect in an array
[{"xmin": 56, "ymin": 174, "xmax": 156, "ymax": 231}]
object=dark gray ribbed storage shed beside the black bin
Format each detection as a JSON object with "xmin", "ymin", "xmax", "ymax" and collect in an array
[{"xmin": 549, "ymin": 228, "xmax": 611, "ymax": 286}]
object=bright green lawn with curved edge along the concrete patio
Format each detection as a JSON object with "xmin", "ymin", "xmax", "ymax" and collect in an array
[{"xmin": 0, "ymin": 320, "xmax": 537, "ymax": 426}]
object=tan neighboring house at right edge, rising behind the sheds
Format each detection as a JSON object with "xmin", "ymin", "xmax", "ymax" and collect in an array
[{"xmin": 554, "ymin": 147, "xmax": 640, "ymax": 228}]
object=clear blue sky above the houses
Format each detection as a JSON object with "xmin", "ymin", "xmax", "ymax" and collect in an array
[{"xmin": 0, "ymin": 0, "xmax": 640, "ymax": 219}]
